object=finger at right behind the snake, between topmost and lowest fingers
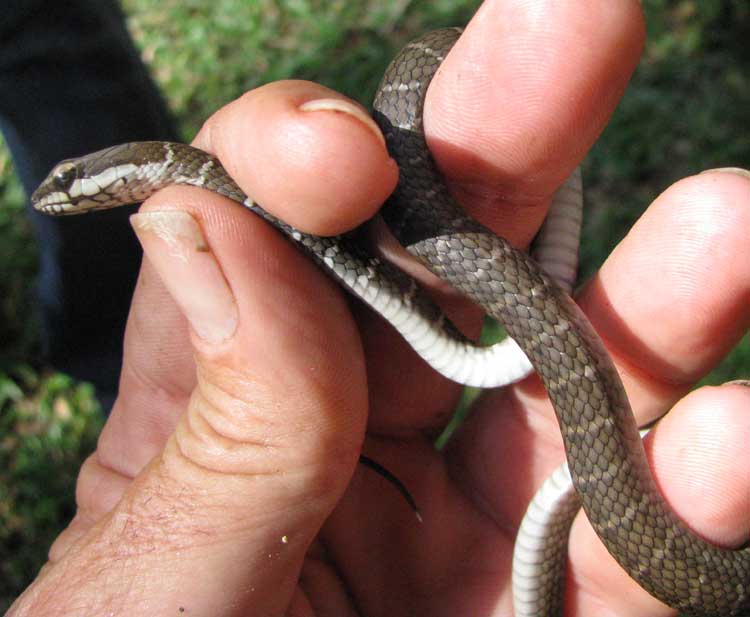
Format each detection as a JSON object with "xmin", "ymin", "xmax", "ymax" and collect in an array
[{"xmin": 455, "ymin": 172, "xmax": 750, "ymax": 523}]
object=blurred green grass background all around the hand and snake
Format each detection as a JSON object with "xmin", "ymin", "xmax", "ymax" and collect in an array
[{"xmin": 0, "ymin": 0, "xmax": 750, "ymax": 610}]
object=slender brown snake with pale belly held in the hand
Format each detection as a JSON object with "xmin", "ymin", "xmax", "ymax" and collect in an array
[{"xmin": 32, "ymin": 28, "xmax": 750, "ymax": 616}]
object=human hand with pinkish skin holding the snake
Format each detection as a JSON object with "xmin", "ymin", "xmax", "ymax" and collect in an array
[{"xmin": 11, "ymin": 2, "xmax": 750, "ymax": 616}]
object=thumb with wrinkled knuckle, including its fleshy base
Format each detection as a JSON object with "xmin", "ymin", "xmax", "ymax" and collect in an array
[{"xmin": 17, "ymin": 180, "xmax": 367, "ymax": 615}]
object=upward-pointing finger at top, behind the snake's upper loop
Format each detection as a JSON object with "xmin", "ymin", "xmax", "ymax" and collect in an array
[{"xmin": 425, "ymin": 0, "xmax": 644, "ymax": 246}]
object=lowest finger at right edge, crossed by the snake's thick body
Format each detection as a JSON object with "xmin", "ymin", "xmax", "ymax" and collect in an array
[{"xmin": 567, "ymin": 385, "xmax": 750, "ymax": 617}]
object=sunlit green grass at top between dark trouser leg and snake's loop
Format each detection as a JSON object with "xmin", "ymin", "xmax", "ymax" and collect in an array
[{"xmin": 124, "ymin": 0, "xmax": 479, "ymax": 137}]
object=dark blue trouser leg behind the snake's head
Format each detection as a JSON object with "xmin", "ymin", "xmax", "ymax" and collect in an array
[{"xmin": 0, "ymin": 0, "xmax": 177, "ymax": 401}]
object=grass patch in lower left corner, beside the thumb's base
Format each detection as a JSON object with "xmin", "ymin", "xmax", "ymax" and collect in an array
[{"xmin": 0, "ymin": 365, "xmax": 102, "ymax": 612}]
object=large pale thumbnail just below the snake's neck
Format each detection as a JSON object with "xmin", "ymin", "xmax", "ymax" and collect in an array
[{"xmin": 130, "ymin": 210, "xmax": 238, "ymax": 343}]
